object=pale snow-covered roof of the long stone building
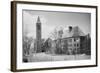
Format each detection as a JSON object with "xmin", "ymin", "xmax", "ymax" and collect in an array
[{"xmin": 49, "ymin": 26, "xmax": 85, "ymax": 40}]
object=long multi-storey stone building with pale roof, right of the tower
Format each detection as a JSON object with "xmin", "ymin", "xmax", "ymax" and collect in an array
[{"xmin": 46, "ymin": 26, "xmax": 91, "ymax": 55}]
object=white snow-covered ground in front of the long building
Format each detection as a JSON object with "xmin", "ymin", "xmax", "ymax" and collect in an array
[{"xmin": 28, "ymin": 53, "xmax": 91, "ymax": 62}]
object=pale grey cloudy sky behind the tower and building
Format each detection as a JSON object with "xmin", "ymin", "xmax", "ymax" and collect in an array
[{"xmin": 23, "ymin": 10, "xmax": 91, "ymax": 38}]
